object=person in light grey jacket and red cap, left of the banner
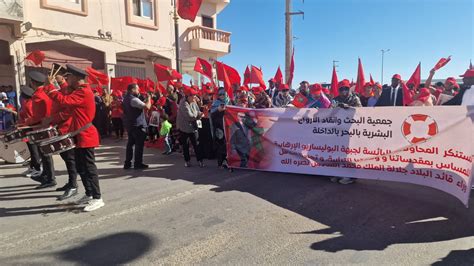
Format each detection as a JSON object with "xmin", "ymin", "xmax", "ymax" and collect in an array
[{"xmin": 177, "ymin": 86, "xmax": 204, "ymax": 167}]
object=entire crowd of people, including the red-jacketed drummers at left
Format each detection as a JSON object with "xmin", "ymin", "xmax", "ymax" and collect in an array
[{"xmin": 0, "ymin": 65, "xmax": 474, "ymax": 211}]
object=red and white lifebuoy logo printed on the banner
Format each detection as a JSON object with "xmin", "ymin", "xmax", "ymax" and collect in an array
[{"xmin": 402, "ymin": 114, "xmax": 438, "ymax": 144}]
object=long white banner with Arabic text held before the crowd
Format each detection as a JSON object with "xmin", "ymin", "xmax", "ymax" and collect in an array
[{"xmin": 225, "ymin": 106, "xmax": 474, "ymax": 206}]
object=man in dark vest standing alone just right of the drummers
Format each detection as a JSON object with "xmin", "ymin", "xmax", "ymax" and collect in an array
[{"xmin": 122, "ymin": 83, "xmax": 151, "ymax": 169}]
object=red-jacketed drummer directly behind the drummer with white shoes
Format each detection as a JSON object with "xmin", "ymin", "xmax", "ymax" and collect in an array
[{"xmin": 24, "ymin": 71, "xmax": 56, "ymax": 189}]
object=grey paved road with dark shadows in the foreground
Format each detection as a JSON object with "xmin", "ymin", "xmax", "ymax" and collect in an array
[{"xmin": 0, "ymin": 140, "xmax": 474, "ymax": 265}]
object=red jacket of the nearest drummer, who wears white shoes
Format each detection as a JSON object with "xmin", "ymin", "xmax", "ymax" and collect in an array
[{"xmin": 49, "ymin": 84, "xmax": 99, "ymax": 148}]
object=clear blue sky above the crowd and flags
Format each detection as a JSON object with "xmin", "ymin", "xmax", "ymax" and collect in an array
[{"xmin": 217, "ymin": 0, "xmax": 474, "ymax": 86}]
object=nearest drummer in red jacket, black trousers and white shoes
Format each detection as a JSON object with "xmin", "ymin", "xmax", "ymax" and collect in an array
[{"xmin": 47, "ymin": 65, "xmax": 104, "ymax": 211}]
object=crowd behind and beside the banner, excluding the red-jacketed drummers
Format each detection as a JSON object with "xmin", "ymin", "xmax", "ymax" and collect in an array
[{"xmin": 112, "ymin": 65, "xmax": 474, "ymax": 184}]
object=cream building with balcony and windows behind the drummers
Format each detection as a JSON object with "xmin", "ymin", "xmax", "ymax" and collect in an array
[{"xmin": 0, "ymin": 0, "xmax": 231, "ymax": 94}]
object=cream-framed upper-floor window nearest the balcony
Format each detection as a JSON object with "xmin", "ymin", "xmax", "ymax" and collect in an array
[{"xmin": 125, "ymin": 0, "xmax": 158, "ymax": 30}]
